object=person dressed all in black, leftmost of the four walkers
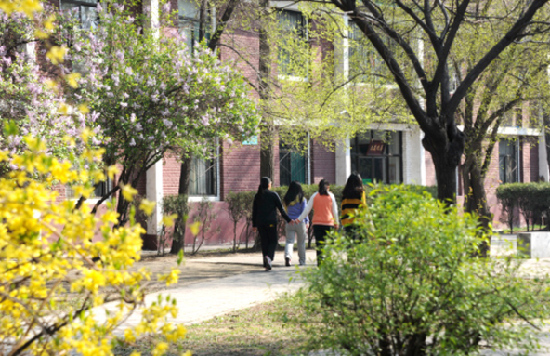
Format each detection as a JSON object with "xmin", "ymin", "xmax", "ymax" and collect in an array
[{"xmin": 252, "ymin": 177, "xmax": 292, "ymax": 271}]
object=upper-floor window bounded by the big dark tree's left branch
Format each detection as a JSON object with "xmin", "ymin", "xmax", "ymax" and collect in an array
[{"xmin": 348, "ymin": 21, "xmax": 388, "ymax": 84}]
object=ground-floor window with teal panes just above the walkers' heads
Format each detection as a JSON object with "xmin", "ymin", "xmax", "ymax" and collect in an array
[{"xmin": 279, "ymin": 141, "xmax": 309, "ymax": 186}]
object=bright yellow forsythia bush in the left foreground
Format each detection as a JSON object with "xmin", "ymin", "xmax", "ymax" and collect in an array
[{"xmin": 0, "ymin": 132, "xmax": 185, "ymax": 356}]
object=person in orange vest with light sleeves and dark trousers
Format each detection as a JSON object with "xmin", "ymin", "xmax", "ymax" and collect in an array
[{"xmin": 294, "ymin": 179, "xmax": 338, "ymax": 266}]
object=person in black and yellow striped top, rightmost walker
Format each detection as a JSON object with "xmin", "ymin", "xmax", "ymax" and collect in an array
[{"xmin": 341, "ymin": 173, "xmax": 367, "ymax": 242}]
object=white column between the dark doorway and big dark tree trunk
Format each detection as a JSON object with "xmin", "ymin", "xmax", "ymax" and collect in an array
[{"xmin": 403, "ymin": 125, "xmax": 426, "ymax": 185}]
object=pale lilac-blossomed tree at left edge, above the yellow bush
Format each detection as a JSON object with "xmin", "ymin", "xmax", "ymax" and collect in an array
[{"xmin": 0, "ymin": 12, "xmax": 85, "ymax": 173}]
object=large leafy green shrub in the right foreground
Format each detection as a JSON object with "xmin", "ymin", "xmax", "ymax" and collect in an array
[{"xmin": 298, "ymin": 186, "xmax": 549, "ymax": 355}]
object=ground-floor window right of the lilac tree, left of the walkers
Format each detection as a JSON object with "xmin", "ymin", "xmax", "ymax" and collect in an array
[{"xmin": 189, "ymin": 157, "xmax": 218, "ymax": 196}]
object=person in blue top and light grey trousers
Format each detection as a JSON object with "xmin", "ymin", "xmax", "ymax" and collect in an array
[{"xmin": 283, "ymin": 181, "xmax": 309, "ymax": 267}]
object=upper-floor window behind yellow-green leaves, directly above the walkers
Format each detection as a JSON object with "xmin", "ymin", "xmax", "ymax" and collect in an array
[{"xmin": 278, "ymin": 10, "xmax": 309, "ymax": 78}]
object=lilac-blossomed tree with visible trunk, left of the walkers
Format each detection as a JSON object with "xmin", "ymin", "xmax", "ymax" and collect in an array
[{"xmin": 68, "ymin": 2, "xmax": 257, "ymax": 223}]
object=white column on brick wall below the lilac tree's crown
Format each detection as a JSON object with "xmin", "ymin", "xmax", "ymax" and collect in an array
[{"xmin": 146, "ymin": 160, "xmax": 164, "ymax": 235}]
